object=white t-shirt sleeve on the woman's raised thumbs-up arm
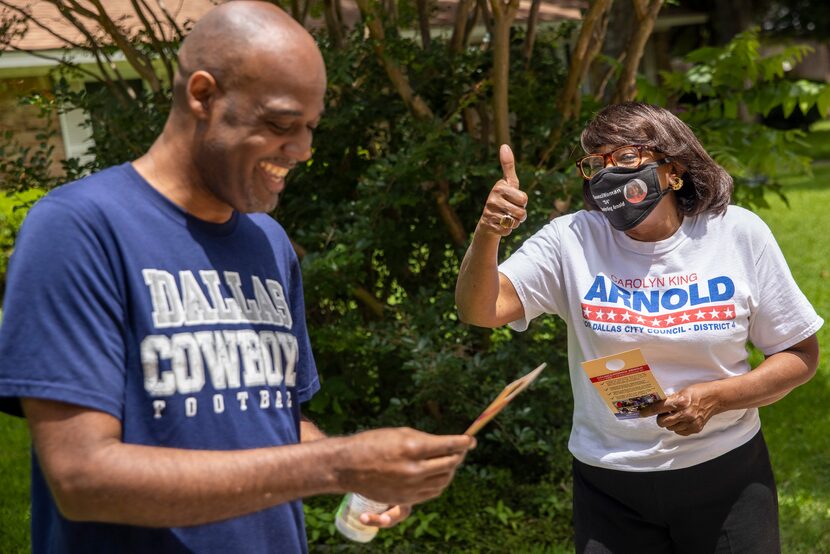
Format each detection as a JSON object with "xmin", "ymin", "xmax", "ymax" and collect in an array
[{"xmin": 499, "ymin": 221, "xmax": 567, "ymax": 331}]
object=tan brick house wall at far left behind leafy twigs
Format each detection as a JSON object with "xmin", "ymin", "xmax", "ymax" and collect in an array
[{"xmin": 0, "ymin": 76, "xmax": 65, "ymax": 182}]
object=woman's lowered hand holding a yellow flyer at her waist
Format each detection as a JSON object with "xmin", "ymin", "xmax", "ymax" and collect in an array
[{"xmin": 640, "ymin": 381, "xmax": 720, "ymax": 436}]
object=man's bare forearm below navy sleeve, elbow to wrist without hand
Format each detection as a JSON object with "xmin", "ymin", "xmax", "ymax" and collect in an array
[{"xmin": 32, "ymin": 404, "xmax": 349, "ymax": 527}]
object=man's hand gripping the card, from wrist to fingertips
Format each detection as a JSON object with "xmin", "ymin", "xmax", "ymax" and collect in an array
[{"xmin": 338, "ymin": 428, "xmax": 475, "ymax": 506}]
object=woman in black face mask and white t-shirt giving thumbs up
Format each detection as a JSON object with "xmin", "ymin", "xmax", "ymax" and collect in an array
[{"xmin": 456, "ymin": 103, "xmax": 823, "ymax": 553}]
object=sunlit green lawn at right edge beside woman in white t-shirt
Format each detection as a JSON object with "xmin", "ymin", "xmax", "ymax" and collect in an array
[{"xmin": 758, "ymin": 157, "xmax": 830, "ymax": 554}]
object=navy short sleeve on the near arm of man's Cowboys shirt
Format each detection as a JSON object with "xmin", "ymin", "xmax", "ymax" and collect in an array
[{"xmin": 0, "ymin": 195, "xmax": 126, "ymax": 419}]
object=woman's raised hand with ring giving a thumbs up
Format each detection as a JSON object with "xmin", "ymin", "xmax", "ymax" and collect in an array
[{"xmin": 478, "ymin": 144, "xmax": 527, "ymax": 237}]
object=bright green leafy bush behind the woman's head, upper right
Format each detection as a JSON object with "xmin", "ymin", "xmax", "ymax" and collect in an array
[{"xmin": 640, "ymin": 25, "xmax": 830, "ymax": 208}]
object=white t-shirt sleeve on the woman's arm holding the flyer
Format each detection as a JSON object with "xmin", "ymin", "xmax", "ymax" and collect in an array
[{"xmin": 749, "ymin": 231, "xmax": 824, "ymax": 355}]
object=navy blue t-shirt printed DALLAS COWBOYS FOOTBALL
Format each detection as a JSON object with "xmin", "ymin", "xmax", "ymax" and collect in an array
[{"xmin": 0, "ymin": 164, "xmax": 319, "ymax": 553}]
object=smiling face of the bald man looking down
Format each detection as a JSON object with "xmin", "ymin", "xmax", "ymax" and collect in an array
[{"xmin": 194, "ymin": 45, "xmax": 326, "ymax": 213}]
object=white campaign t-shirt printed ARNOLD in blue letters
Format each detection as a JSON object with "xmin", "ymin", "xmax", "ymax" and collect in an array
[{"xmin": 499, "ymin": 206, "xmax": 823, "ymax": 471}]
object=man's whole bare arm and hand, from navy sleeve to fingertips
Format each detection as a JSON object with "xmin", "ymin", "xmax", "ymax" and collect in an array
[{"xmin": 23, "ymin": 399, "xmax": 473, "ymax": 527}]
